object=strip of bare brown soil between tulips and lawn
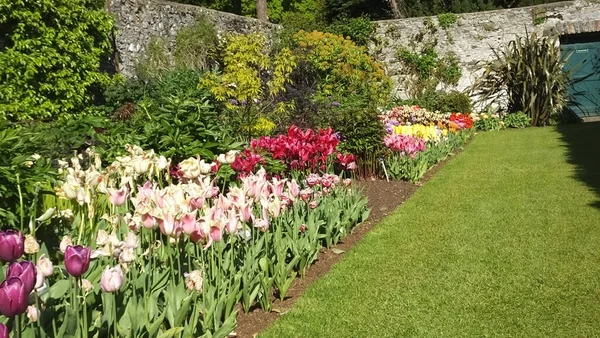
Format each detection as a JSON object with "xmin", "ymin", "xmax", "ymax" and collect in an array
[{"xmin": 231, "ymin": 147, "xmax": 466, "ymax": 338}]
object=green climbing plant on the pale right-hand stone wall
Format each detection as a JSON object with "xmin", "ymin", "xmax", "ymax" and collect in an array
[{"xmin": 398, "ymin": 19, "xmax": 461, "ymax": 99}]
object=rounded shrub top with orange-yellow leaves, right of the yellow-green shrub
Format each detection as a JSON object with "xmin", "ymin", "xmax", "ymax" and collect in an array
[{"xmin": 295, "ymin": 31, "xmax": 391, "ymax": 104}]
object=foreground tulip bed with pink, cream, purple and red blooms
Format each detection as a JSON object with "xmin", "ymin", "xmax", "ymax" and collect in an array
[{"xmin": 0, "ymin": 139, "xmax": 368, "ymax": 337}]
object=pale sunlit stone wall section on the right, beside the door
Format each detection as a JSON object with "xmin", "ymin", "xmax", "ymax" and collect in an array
[{"xmin": 371, "ymin": 1, "xmax": 600, "ymax": 98}]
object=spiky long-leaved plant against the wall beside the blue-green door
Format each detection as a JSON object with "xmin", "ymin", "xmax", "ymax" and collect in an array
[{"xmin": 471, "ymin": 33, "xmax": 570, "ymax": 126}]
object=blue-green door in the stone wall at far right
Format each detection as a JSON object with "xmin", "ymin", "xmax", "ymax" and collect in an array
[{"xmin": 561, "ymin": 39, "xmax": 600, "ymax": 118}]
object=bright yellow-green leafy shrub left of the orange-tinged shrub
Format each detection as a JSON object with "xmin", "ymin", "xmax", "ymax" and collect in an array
[{"xmin": 200, "ymin": 34, "xmax": 296, "ymax": 140}]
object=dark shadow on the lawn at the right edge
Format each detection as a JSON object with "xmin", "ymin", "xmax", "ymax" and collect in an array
[{"xmin": 558, "ymin": 122, "xmax": 600, "ymax": 209}]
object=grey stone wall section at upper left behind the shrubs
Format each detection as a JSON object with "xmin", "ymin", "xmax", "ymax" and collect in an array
[{"xmin": 107, "ymin": 0, "xmax": 278, "ymax": 76}]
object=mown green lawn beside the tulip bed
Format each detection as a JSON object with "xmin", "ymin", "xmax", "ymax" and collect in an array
[{"xmin": 260, "ymin": 124, "xmax": 600, "ymax": 338}]
